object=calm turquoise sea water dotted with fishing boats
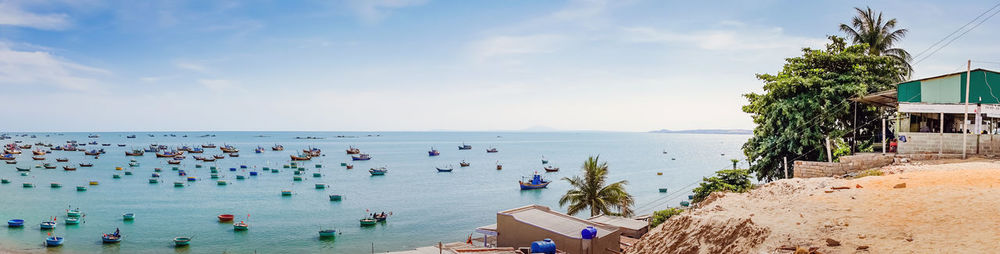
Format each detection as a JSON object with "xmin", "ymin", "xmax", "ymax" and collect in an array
[{"xmin": 0, "ymin": 132, "xmax": 749, "ymax": 253}]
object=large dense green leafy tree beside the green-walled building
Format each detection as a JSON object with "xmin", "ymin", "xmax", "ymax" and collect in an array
[{"xmin": 743, "ymin": 36, "xmax": 901, "ymax": 181}]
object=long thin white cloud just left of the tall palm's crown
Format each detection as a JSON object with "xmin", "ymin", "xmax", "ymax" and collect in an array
[{"xmin": 623, "ymin": 27, "xmax": 826, "ymax": 50}]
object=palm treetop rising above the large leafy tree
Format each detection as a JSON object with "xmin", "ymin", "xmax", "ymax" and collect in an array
[{"xmin": 840, "ymin": 7, "xmax": 913, "ymax": 78}]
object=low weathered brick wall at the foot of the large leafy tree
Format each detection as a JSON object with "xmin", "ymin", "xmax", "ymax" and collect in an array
[{"xmin": 792, "ymin": 153, "xmax": 895, "ymax": 178}]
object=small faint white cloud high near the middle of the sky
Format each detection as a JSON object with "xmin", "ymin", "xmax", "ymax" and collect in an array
[{"xmin": 471, "ymin": 34, "xmax": 566, "ymax": 61}]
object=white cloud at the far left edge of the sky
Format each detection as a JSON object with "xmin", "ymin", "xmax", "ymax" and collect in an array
[{"xmin": 0, "ymin": 43, "xmax": 110, "ymax": 91}]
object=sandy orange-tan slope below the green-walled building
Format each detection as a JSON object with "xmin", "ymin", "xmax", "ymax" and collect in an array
[{"xmin": 628, "ymin": 159, "xmax": 1000, "ymax": 253}]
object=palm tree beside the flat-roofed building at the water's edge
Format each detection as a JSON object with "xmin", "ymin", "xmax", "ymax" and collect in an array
[{"xmin": 559, "ymin": 156, "xmax": 635, "ymax": 217}]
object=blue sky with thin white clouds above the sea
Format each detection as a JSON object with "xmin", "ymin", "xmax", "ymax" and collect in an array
[{"xmin": 0, "ymin": 0, "xmax": 1000, "ymax": 132}]
